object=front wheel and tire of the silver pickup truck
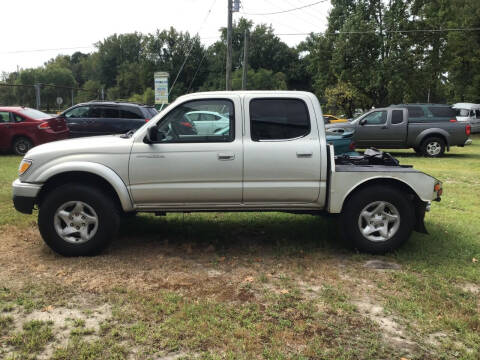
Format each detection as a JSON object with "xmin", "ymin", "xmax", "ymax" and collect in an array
[{"xmin": 38, "ymin": 183, "xmax": 120, "ymax": 256}]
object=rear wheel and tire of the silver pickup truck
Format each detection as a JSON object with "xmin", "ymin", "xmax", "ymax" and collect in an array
[{"xmin": 341, "ymin": 185, "xmax": 415, "ymax": 254}]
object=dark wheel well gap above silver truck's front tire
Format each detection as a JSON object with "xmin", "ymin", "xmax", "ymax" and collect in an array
[{"xmin": 36, "ymin": 171, "xmax": 122, "ymax": 211}]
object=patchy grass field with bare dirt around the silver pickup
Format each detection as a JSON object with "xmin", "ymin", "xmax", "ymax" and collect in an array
[{"xmin": 0, "ymin": 136, "xmax": 480, "ymax": 359}]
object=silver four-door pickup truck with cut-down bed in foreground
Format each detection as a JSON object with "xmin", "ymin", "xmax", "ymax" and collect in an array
[{"xmin": 13, "ymin": 91, "xmax": 442, "ymax": 256}]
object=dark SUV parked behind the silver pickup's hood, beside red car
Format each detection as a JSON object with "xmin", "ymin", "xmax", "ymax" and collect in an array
[{"xmin": 59, "ymin": 101, "xmax": 157, "ymax": 137}]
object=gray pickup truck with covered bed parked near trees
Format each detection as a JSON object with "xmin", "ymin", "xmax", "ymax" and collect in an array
[{"xmin": 326, "ymin": 104, "xmax": 471, "ymax": 157}]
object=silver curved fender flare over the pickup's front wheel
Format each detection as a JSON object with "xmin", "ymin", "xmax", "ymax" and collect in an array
[{"xmin": 35, "ymin": 161, "xmax": 134, "ymax": 211}]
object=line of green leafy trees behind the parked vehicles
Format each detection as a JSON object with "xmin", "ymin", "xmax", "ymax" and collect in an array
[{"xmin": 0, "ymin": 0, "xmax": 480, "ymax": 117}]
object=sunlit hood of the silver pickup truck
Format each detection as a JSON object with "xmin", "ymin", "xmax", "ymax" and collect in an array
[{"xmin": 25, "ymin": 135, "xmax": 133, "ymax": 159}]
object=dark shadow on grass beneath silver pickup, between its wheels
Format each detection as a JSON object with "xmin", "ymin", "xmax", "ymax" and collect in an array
[{"xmin": 113, "ymin": 213, "xmax": 349, "ymax": 256}]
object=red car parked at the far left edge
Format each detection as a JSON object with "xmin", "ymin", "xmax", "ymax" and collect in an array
[{"xmin": 0, "ymin": 106, "xmax": 68, "ymax": 155}]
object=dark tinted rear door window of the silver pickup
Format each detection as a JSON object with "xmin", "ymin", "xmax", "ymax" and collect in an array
[{"xmin": 250, "ymin": 99, "xmax": 310, "ymax": 141}]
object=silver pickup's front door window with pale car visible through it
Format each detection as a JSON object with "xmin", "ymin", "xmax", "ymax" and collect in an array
[{"xmin": 157, "ymin": 99, "xmax": 235, "ymax": 143}]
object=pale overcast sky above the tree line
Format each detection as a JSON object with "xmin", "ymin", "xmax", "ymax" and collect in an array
[{"xmin": 0, "ymin": 0, "xmax": 331, "ymax": 74}]
